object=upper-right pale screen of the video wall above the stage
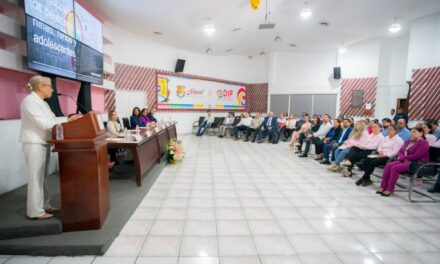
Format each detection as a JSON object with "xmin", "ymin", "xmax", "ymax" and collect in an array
[{"xmin": 75, "ymin": 2, "xmax": 103, "ymax": 53}]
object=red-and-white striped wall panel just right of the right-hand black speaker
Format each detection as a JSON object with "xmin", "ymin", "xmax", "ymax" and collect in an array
[{"xmin": 339, "ymin": 77, "xmax": 377, "ymax": 116}]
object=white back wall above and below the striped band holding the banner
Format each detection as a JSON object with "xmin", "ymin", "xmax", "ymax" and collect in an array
[{"xmin": 108, "ymin": 22, "xmax": 268, "ymax": 134}]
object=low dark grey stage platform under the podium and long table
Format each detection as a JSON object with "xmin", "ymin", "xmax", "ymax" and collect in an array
[{"xmin": 0, "ymin": 159, "xmax": 166, "ymax": 256}]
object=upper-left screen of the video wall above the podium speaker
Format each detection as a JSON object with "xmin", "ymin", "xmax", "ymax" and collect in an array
[{"xmin": 24, "ymin": 0, "xmax": 75, "ymax": 37}]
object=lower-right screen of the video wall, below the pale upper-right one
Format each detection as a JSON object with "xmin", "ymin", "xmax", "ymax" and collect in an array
[{"xmin": 76, "ymin": 42, "xmax": 104, "ymax": 84}]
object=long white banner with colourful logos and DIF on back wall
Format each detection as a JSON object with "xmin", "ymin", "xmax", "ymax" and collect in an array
[{"xmin": 157, "ymin": 74, "xmax": 246, "ymax": 110}]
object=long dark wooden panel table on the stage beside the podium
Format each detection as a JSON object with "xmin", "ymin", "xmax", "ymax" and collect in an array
[{"xmin": 107, "ymin": 123, "xmax": 177, "ymax": 186}]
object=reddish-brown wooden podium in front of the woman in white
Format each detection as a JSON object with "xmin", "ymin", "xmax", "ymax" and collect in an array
[{"xmin": 49, "ymin": 112, "xmax": 109, "ymax": 231}]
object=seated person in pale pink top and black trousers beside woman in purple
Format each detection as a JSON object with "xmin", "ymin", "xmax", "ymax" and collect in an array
[{"xmin": 356, "ymin": 125, "xmax": 403, "ymax": 186}]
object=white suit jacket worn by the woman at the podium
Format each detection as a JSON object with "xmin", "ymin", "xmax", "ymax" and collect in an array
[{"xmin": 20, "ymin": 92, "xmax": 58, "ymax": 144}]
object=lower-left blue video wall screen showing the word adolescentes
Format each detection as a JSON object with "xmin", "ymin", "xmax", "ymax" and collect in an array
[{"xmin": 26, "ymin": 16, "xmax": 77, "ymax": 78}]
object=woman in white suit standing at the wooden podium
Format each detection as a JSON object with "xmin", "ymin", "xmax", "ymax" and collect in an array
[{"xmin": 20, "ymin": 76, "xmax": 78, "ymax": 219}]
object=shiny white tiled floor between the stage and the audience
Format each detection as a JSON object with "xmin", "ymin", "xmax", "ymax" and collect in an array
[{"xmin": 0, "ymin": 136, "xmax": 440, "ymax": 264}]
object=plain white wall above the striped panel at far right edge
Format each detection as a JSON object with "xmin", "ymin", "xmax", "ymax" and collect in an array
[{"xmin": 406, "ymin": 14, "xmax": 440, "ymax": 80}]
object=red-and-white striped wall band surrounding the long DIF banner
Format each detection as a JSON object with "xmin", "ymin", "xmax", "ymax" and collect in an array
[{"xmin": 105, "ymin": 63, "xmax": 268, "ymax": 112}]
